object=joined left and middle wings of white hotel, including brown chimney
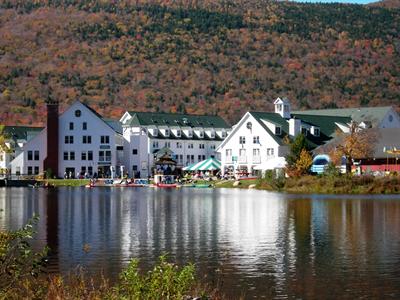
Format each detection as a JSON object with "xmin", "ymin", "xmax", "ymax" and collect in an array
[{"xmin": 2, "ymin": 101, "xmax": 230, "ymax": 178}]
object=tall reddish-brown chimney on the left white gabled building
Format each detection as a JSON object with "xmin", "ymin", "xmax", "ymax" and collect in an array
[{"xmin": 43, "ymin": 95, "xmax": 59, "ymax": 177}]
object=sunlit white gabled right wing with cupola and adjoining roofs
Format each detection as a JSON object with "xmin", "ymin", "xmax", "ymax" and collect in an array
[{"xmin": 217, "ymin": 98, "xmax": 400, "ymax": 173}]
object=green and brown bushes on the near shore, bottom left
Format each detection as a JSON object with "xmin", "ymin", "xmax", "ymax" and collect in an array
[{"xmin": 0, "ymin": 217, "xmax": 222, "ymax": 300}]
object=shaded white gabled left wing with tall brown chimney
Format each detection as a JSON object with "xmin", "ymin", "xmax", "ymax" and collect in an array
[{"xmin": 10, "ymin": 101, "xmax": 123, "ymax": 178}]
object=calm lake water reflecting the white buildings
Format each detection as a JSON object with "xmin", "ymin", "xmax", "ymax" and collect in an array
[{"xmin": 0, "ymin": 188, "xmax": 400, "ymax": 299}]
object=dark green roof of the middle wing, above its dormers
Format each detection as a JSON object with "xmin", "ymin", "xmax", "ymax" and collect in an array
[{"xmin": 123, "ymin": 111, "xmax": 229, "ymax": 128}]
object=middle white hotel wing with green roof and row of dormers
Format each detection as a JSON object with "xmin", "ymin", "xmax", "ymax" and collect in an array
[{"xmin": 120, "ymin": 111, "xmax": 229, "ymax": 177}]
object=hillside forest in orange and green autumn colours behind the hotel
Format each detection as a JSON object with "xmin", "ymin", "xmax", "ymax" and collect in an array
[{"xmin": 0, "ymin": 0, "xmax": 400, "ymax": 124}]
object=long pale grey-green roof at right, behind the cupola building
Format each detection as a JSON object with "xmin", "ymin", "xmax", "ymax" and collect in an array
[{"xmin": 292, "ymin": 106, "xmax": 393, "ymax": 127}]
